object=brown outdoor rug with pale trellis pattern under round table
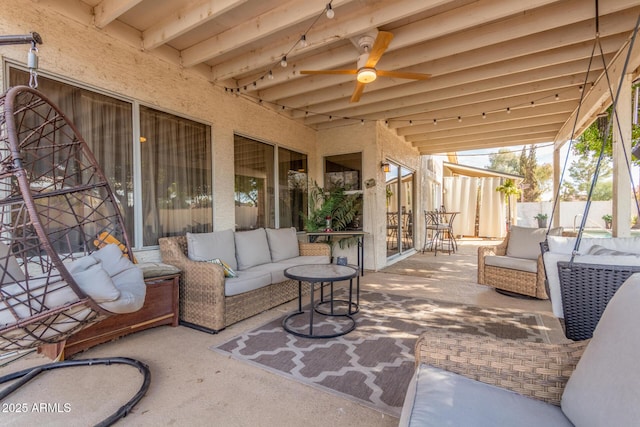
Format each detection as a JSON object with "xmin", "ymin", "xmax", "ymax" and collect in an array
[{"xmin": 211, "ymin": 291, "xmax": 549, "ymax": 417}]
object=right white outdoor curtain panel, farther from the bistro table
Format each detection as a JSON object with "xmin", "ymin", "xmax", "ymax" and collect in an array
[{"xmin": 478, "ymin": 178, "xmax": 506, "ymax": 237}]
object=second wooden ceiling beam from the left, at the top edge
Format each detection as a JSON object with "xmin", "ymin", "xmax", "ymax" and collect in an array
[{"xmin": 142, "ymin": 0, "xmax": 247, "ymax": 50}]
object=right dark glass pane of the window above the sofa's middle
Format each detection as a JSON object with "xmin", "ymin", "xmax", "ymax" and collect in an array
[{"xmin": 278, "ymin": 148, "xmax": 307, "ymax": 231}]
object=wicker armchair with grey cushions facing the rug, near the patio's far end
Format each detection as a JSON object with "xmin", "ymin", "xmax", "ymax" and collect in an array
[{"xmin": 478, "ymin": 225, "xmax": 562, "ymax": 299}]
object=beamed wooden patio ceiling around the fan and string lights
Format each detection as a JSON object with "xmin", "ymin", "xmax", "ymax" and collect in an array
[{"xmin": 42, "ymin": 0, "xmax": 640, "ymax": 154}]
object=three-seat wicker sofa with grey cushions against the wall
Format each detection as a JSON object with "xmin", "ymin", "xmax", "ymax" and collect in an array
[{"xmin": 159, "ymin": 228, "xmax": 330, "ymax": 333}]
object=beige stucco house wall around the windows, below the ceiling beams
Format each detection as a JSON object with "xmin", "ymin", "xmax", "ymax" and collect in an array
[{"xmin": 0, "ymin": 0, "xmax": 419, "ymax": 269}]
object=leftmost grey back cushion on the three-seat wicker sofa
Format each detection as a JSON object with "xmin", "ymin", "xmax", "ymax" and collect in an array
[{"xmin": 187, "ymin": 230, "xmax": 238, "ymax": 270}]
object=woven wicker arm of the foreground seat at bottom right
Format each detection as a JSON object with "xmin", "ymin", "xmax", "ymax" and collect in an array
[{"xmin": 415, "ymin": 330, "xmax": 588, "ymax": 406}]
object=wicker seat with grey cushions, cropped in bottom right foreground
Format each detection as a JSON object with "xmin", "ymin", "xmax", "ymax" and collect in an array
[{"xmin": 400, "ymin": 274, "xmax": 640, "ymax": 426}]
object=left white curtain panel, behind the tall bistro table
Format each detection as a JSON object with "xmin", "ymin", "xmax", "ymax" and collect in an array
[{"xmin": 443, "ymin": 176, "xmax": 478, "ymax": 236}]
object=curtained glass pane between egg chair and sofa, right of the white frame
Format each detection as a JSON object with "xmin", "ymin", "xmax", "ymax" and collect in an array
[{"xmin": 140, "ymin": 106, "xmax": 213, "ymax": 246}]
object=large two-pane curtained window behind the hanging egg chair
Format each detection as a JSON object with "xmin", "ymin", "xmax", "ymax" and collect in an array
[{"xmin": 9, "ymin": 67, "xmax": 213, "ymax": 247}]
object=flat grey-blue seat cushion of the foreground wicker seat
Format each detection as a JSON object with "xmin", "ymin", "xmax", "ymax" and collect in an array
[{"xmin": 400, "ymin": 364, "xmax": 573, "ymax": 427}]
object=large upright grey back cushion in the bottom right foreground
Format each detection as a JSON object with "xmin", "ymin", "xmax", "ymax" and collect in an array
[{"xmin": 562, "ymin": 273, "xmax": 640, "ymax": 426}]
